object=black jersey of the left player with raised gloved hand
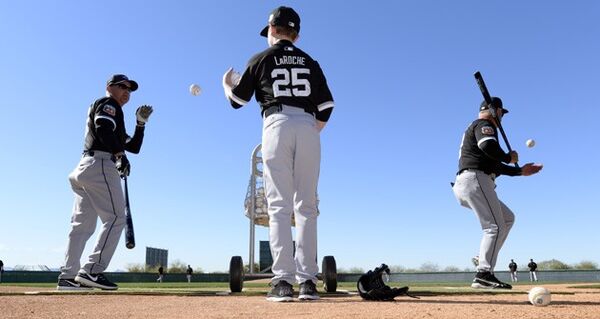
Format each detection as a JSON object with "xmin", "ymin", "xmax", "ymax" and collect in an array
[{"xmin": 84, "ymin": 97, "xmax": 144, "ymax": 154}]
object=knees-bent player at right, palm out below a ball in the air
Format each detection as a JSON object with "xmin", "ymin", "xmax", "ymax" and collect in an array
[{"xmin": 452, "ymin": 97, "xmax": 542, "ymax": 289}]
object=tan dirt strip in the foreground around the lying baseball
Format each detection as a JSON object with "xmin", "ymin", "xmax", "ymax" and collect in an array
[{"xmin": 0, "ymin": 285, "xmax": 600, "ymax": 319}]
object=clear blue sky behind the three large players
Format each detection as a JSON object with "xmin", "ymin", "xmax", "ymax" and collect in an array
[{"xmin": 0, "ymin": 0, "xmax": 600, "ymax": 271}]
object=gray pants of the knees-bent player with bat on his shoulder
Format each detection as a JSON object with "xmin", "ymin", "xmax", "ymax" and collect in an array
[{"xmin": 453, "ymin": 170, "xmax": 515, "ymax": 272}]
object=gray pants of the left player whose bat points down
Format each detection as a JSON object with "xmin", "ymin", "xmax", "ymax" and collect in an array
[{"xmin": 59, "ymin": 151, "xmax": 125, "ymax": 279}]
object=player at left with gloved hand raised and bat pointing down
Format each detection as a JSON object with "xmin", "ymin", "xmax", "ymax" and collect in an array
[{"xmin": 57, "ymin": 74, "xmax": 152, "ymax": 290}]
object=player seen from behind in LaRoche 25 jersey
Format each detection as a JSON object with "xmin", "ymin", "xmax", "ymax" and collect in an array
[{"xmin": 223, "ymin": 7, "xmax": 334, "ymax": 301}]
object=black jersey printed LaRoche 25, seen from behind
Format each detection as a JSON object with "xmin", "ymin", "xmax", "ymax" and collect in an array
[{"xmin": 229, "ymin": 40, "xmax": 334, "ymax": 122}]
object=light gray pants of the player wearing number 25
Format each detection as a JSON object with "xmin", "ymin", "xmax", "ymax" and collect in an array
[{"xmin": 262, "ymin": 106, "xmax": 321, "ymax": 284}]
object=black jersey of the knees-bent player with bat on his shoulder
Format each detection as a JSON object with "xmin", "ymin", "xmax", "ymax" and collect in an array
[{"xmin": 458, "ymin": 119, "xmax": 521, "ymax": 176}]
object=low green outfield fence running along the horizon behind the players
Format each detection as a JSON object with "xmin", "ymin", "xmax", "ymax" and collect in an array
[{"xmin": 2, "ymin": 270, "xmax": 600, "ymax": 283}]
